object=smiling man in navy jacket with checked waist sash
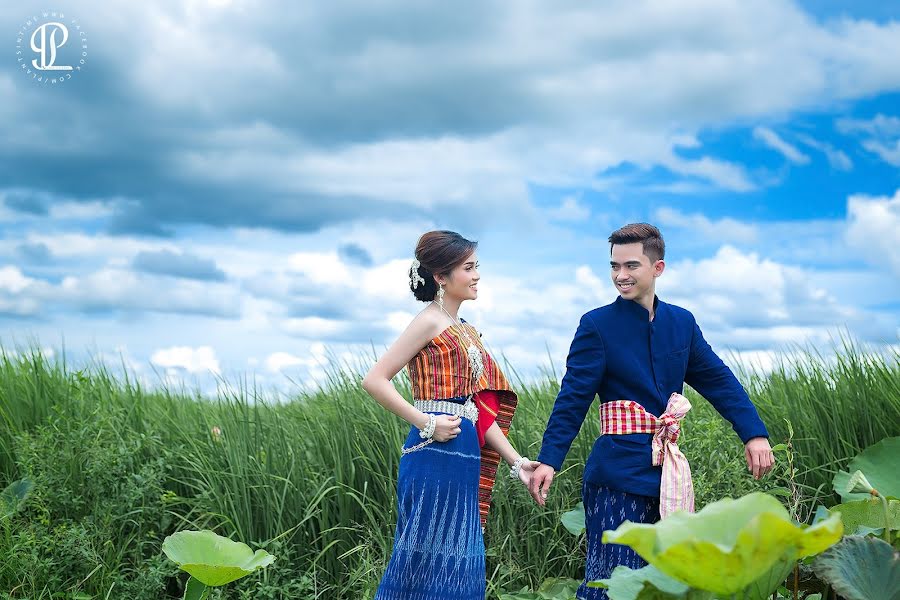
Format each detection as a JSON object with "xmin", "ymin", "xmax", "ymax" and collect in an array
[{"xmin": 529, "ymin": 223, "xmax": 774, "ymax": 600}]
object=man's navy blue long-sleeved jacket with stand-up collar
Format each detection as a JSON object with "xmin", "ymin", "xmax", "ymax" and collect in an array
[{"xmin": 538, "ymin": 296, "xmax": 769, "ymax": 497}]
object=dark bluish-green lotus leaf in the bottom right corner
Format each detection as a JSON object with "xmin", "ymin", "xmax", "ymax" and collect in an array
[{"xmin": 814, "ymin": 536, "xmax": 900, "ymax": 600}]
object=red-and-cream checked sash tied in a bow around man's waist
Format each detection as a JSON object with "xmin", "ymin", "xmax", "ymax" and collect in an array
[{"xmin": 600, "ymin": 392, "xmax": 694, "ymax": 518}]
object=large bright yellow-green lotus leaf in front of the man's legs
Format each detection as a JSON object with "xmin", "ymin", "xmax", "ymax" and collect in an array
[{"xmin": 603, "ymin": 492, "xmax": 843, "ymax": 595}]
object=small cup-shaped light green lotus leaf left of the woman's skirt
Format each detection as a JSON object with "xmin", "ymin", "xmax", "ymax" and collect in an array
[{"xmin": 163, "ymin": 530, "xmax": 275, "ymax": 586}]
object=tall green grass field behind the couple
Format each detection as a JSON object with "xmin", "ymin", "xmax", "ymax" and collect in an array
[{"xmin": 0, "ymin": 345, "xmax": 900, "ymax": 599}]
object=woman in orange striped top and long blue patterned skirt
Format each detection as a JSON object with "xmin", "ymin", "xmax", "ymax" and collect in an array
[{"xmin": 363, "ymin": 231, "xmax": 537, "ymax": 600}]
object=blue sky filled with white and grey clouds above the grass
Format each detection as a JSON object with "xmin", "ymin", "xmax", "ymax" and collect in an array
[{"xmin": 0, "ymin": 0, "xmax": 900, "ymax": 394}]
